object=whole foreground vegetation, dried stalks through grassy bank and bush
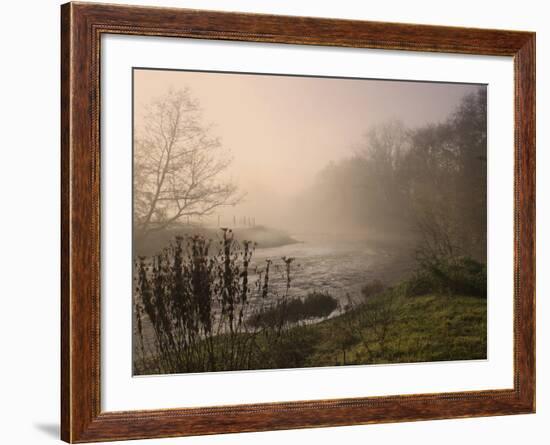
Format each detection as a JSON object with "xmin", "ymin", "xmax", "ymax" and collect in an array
[{"xmin": 134, "ymin": 230, "xmax": 487, "ymax": 374}]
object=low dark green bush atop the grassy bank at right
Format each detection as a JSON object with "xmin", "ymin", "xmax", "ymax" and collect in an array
[{"xmin": 407, "ymin": 257, "xmax": 487, "ymax": 298}]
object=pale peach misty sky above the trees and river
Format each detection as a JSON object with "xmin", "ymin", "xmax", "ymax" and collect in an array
[{"xmin": 134, "ymin": 70, "xmax": 484, "ymax": 229}]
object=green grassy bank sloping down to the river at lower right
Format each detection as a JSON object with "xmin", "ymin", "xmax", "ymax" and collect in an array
[{"xmin": 138, "ymin": 292, "xmax": 487, "ymax": 373}]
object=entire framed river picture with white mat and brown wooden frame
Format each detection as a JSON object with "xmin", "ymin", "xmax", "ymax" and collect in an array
[{"xmin": 61, "ymin": 3, "xmax": 535, "ymax": 443}]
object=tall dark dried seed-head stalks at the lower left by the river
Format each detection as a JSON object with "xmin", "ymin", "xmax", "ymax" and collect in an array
[{"xmin": 134, "ymin": 230, "xmax": 260, "ymax": 373}]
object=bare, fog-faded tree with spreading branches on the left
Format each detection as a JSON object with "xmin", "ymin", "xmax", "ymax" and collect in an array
[{"xmin": 134, "ymin": 88, "xmax": 240, "ymax": 238}]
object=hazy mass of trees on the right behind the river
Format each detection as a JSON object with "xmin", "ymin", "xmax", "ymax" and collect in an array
[{"xmin": 298, "ymin": 87, "xmax": 487, "ymax": 262}]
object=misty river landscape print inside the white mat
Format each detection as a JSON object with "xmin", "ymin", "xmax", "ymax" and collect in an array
[{"xmin": 132, "ymin": 68, "xmax": 487, "ymax": 375}]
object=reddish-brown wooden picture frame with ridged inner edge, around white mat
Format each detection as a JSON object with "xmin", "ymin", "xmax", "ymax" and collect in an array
[{"xmin": 61, "ymin": 3, "xmax": 535, "ymax": 443}]
